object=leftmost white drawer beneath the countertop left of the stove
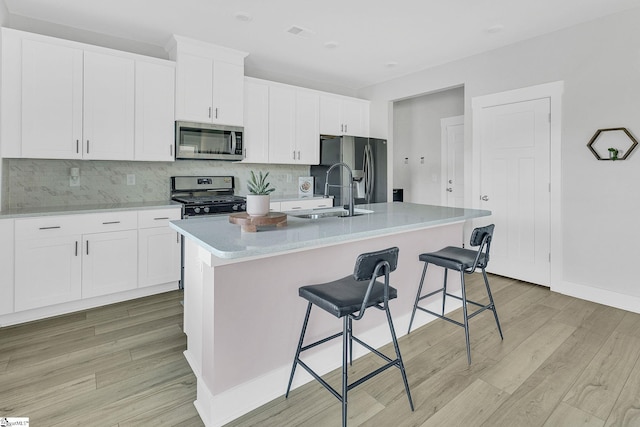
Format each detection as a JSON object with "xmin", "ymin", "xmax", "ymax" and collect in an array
[{"xmin": 15, "ymin": 215, "xmax": 83, "ymax": 240}]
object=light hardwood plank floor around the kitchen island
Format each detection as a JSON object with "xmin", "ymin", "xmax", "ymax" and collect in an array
[{"xmin": 0, "ymin": 276, "xmax": 640, "ymax": 427}]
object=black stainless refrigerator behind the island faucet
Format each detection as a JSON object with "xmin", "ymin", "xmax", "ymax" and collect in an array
[{"xmin": 311, "ymin": 136, "xmax": 387, "ymax": 206}]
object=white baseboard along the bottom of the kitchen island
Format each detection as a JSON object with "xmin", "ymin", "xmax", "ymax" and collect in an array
[{"xmin": 191, "ymin": 298, "xmax": 462, "ymax": 427}]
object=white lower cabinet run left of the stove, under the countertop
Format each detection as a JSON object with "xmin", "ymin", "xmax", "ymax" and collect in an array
[{"xmin": 12, "ymin": 206, "xmax": 180, "ymax": 315}]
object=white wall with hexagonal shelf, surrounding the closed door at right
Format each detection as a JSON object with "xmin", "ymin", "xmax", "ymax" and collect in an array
[{"xmin": 360, "ymin": 9, "xmax": 640, "ymax": 311}]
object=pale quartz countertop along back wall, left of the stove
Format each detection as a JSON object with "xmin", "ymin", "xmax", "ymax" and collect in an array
[{"xmin": 0, "ymin": 200, "xmax": 181, "ymax": 219}]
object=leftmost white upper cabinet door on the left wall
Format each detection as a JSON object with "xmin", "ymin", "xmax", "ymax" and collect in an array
[{"xmin": 22, "ymin": 40, "xmax": 83, "ymax": 159}]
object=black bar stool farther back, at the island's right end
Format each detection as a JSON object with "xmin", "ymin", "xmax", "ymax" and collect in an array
[{"xmin": 407, "ymin": 224, "xmax": 504, "ymax": 364}]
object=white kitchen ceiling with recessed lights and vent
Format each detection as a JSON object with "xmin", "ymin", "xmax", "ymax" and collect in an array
[{"xmin": 5, "ymin": 0, "xmax": 640, "ymax": 91}]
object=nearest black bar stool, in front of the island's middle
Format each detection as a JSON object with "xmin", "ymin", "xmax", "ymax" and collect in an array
[{"xmin": 285, "ymin": 248, "xmax": 413, "ymax": 426}]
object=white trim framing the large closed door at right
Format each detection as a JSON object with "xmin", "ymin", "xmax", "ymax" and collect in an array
[{"xmin": 471, "ymin": 81, "xmax": 564, "ymax": 288}]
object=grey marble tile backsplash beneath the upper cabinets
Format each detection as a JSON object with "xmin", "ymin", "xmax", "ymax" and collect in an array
[{"xmin": 2, "ymin": 159, "xmax": 309, "ymax": 210}]
